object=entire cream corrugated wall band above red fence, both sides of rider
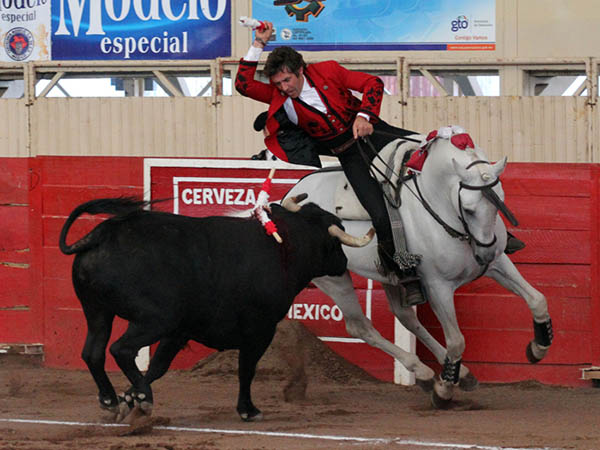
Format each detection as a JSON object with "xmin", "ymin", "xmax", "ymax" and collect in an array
[{"xmin": 0, "ymin": 95, "xmax": 600, "ymax": 162}]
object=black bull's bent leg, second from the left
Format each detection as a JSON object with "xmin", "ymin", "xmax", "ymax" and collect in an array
[{"xmin": 110, "ymin": 323, "xmax": 164, "ymax": 421}]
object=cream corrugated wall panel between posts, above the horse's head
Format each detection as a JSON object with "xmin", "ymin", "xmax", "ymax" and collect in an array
[{"xmin": 404, "ymin": 97, "xmax": 590, "ymax": 162}]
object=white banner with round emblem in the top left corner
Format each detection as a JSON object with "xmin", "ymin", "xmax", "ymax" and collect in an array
[{"xmin": 0, "ymin": 0, "xmax": 50, "ymax": 62}]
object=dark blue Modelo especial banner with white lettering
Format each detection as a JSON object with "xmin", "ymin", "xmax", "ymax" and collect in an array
[{"xmin": 51, "ymin": 0, "xmax": 231, "ymax": 60}]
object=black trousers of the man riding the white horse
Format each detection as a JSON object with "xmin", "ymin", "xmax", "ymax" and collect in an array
[{"xmin": 338, "ymin": 120, "xmax": 414, "ymax": 264}]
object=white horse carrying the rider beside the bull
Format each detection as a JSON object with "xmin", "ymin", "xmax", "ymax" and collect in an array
[{"xmin": 287, "ymin": 127, "xmax": 552, "ymax": 408}]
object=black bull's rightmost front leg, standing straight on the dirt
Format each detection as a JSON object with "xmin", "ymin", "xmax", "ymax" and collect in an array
[{"xmin": 237, "ymin": 326, "xmax": 276, "ymax": 422}]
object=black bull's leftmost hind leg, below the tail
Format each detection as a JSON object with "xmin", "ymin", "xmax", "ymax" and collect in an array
[{"xmin": 81, "ymin": 302, "xmax": 119, "ymax": 414}]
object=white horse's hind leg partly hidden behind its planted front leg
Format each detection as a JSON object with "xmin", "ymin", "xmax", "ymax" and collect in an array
[{"xmin": 383, "ymin": 284, "xmax": 479, "ymax": 391}]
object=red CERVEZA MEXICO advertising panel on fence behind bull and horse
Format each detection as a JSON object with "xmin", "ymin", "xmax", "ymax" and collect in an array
[{"xmin": 144, "ymin": 158, "xmax": 406, "ymax": 381}]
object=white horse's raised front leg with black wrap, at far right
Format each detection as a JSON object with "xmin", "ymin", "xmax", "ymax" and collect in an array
[{"xmin": 486, "ymin": 254, "xmax": 553, "ymax": 363}]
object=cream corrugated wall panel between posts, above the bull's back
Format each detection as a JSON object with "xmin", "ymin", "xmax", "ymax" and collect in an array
[{"xmin": 32, "ymin": 97, "xmax": 217, "ymax": 157}]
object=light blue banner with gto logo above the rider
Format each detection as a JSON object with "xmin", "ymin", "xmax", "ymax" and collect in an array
[{"xmin": 252, "ymin": 0, "xmax": 496, "ymax": 51}]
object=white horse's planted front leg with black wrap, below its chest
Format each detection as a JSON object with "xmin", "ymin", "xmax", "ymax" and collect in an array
[{"xmin": 428, "ymin": 282, "xmax": 465, "ymax": 408}]
